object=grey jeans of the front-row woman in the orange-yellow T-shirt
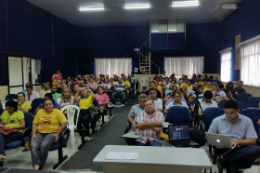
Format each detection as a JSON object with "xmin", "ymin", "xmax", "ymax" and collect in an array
[{"xmin": 31, "ymin": 133, "xmax": 56, "ymax": 167}]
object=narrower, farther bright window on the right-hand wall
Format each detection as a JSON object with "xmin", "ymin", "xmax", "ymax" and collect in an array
[{"xmin": 219, "ymin": 48, "xmax": 232, "ymax": 82}]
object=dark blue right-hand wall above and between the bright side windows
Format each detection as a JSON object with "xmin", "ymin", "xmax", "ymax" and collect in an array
[{"xmin": 220, "ymin": 0, "xmax": 260, "ymax": 80}]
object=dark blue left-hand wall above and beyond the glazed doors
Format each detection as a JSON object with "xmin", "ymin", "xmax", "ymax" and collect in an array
[{"xmin": 0, "ymin": 0, "xmax": 78, "ymax": 85}]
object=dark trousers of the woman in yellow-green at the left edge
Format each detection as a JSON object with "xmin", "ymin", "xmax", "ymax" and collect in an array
[{"xmin": 0, "ymin": 132, "xmax": 22, "ymax": 166}]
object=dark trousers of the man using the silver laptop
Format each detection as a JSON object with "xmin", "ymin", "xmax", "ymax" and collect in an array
[{"xmin": 216, "ymin": 145, "xmax": 260, "ymax": 173}]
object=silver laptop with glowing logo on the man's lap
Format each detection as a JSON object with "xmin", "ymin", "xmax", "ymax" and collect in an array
[{"xmin": 205, "ymin": 132, "xmax": 234, "ymax": 149}]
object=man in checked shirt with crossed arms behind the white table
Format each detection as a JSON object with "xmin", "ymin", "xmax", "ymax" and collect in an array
[{"xmin": 136, "ymin": 98, "xmax": 164, "ymax": 147}]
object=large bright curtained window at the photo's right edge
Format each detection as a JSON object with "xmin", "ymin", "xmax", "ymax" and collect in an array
[{"xmin": 240, "ymin": 38, "xmax": 260, "ymax": 87}]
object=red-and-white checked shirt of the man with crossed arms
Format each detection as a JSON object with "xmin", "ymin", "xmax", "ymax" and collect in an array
[{"xmin": 137, "ymin": 111, "xmax": 164, "ymax": 144}]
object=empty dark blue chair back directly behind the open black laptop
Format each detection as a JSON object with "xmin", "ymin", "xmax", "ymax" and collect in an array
[{"xmin": 166, "ymin": 106, "xmax": 191, "ymax": 125}]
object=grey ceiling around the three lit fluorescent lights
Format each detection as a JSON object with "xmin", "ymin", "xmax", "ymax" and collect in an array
[{"xmin": 27, "ymin": 0, "xmax": 241, "ymax": 26}]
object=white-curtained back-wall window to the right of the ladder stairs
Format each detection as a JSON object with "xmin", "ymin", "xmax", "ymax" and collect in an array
[{"xmin": 164, "ymin": 57, "xmax": 204, "ymax": 76}]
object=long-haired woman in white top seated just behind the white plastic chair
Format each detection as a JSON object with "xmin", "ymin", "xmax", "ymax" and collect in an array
[{"xmin": 57, "ymin": 87, "xmax": 74, "ymax": 109}]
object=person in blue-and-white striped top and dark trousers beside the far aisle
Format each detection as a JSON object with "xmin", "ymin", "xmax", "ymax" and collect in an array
[{"xmin": 112, "ymin": 78, "xmax": 127, "ymax": 107}]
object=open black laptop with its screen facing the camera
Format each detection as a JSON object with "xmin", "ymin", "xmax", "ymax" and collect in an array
[{"xmin": 168, "ymin": 125, "xmax": 199, "ymax": 147}]
